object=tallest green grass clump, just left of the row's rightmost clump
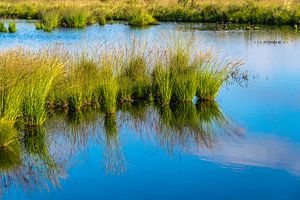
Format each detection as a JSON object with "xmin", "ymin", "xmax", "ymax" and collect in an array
[{"xmin": 152, "ymin": 38, "xmax": 198, "ymax": 105}]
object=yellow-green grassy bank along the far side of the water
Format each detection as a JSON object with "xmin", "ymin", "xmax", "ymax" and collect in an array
[{"xmin": 0, "ymin": 0, "xmax": 300, "ymax": 30}]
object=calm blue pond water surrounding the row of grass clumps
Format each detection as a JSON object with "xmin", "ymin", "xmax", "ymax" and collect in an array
[{"xmin": 0, "ymin": 21, "xmax": 300, "ymax": 200}]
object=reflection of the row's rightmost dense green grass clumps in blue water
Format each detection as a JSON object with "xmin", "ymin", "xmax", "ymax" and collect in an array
[{"xmin": 157, "ymin": 102, "xmax": 228, "ymax": 151}]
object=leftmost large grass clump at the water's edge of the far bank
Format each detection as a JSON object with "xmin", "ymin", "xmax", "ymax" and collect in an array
[{"xmin": 36, "ymin": 9, "xmax": 61, "ymax": 32}]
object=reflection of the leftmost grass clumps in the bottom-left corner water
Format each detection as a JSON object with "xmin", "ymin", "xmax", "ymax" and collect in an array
[{"xmin": 0, "ymin": 128, "xmax": 65, "ymax": 198}]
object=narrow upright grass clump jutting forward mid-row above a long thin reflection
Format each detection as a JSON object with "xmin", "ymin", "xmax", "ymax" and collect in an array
[{"xmin": 99, "ymin": 55, "xmax": 119, "ymax": 114}]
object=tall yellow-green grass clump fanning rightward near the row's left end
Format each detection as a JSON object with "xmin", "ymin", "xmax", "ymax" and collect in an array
[{"xmin": 20, "ymin": 52, "xmax": 64, "ymax": 126}]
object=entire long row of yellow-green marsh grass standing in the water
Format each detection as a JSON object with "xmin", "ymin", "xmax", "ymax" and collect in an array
[{"xmin": 0, "ymin": 40, "xmax": 247, "ymax": 133}]
